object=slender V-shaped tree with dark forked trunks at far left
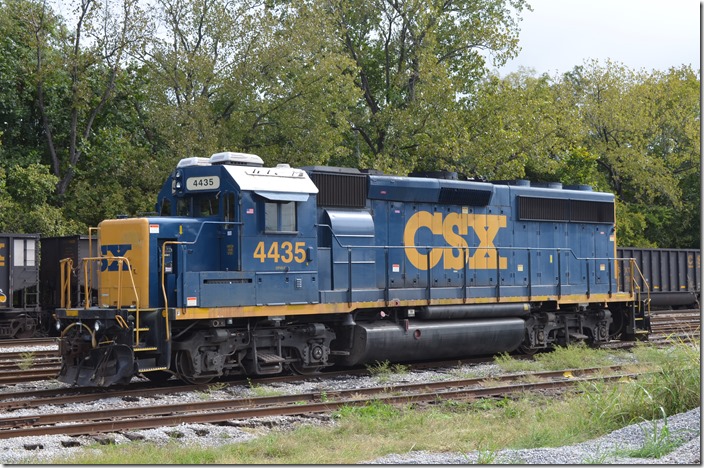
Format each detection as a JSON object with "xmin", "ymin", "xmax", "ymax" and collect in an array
[{"xmin": 24, "ymin": 0, "xmax": 145, "ymax": 197}]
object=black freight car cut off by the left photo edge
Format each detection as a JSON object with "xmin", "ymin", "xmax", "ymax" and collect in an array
[{"xmin": 0, "ymin": 233, "xmax": 41, "ymax": 338}]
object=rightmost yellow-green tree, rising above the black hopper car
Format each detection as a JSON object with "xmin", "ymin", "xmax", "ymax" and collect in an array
[{"xmin": 561, "ymin": 61, "xmax": 700, "ymax": 247}]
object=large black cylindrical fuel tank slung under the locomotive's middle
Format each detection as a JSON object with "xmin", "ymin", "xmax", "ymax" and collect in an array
[{"xmin": 340, "ymin": 318, "xmax": 526, "ymax": 366}]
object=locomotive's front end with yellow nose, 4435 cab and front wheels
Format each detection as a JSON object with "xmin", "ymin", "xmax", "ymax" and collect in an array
[{"xmin": 57, "ymin": 153, "xmax": 333, "ymax": 385}]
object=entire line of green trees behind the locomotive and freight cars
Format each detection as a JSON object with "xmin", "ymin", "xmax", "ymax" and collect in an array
[{"xmin": 0, "ymin": 0, "xmax": 701, "ymax": 247}]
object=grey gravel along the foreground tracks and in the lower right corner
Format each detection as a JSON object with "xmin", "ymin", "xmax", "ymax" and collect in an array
[{"xmin": 0, "ymin": 358, "xmax": 701, "ymax": 464}]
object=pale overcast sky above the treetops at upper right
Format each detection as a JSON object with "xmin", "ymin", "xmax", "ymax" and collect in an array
[{"xmin": 497, "ymin": 0, "xmax": 701, "ymax": 76}]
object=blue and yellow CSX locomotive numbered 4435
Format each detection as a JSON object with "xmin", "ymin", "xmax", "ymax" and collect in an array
[{"xmin": 55, "ymin": 152, "xmax": 649, "ymax": 386}]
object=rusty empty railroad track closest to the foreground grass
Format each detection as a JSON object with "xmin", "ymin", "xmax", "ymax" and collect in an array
[{"xmin": 0, "ymin": 366, "xmax": 634, "ymax": 439}]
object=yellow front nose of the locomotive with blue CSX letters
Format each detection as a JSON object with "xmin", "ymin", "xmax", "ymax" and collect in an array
[{"xmin": 99, "ymin": 218, "xmax": 149, "ymax": 308}]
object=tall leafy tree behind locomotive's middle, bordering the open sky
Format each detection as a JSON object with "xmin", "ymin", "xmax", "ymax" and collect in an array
[{"xmin": 324, "ymin": 0, "xmax": 527, "ymax": 172}]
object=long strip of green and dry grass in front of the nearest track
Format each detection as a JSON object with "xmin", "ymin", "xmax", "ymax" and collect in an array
[{"xmin": 44, "ymin": 343, "xmax": 700, "ymax": 464}]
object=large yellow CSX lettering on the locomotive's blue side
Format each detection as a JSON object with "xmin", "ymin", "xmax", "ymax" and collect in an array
[{"xmin": 403, "ymin": 211, "xmax": 508, "ymax": 270}]
